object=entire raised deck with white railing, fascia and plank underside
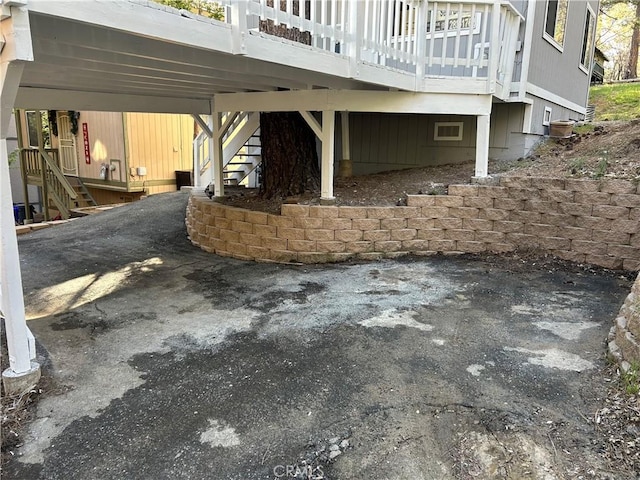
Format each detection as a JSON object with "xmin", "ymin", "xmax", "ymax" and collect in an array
[{"xmin": 7, "ymin": 0, "xmax": 520, "ymax": 114}]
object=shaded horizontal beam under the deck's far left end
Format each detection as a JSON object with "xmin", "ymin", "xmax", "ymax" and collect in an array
[{"xmin": 15, "ymin": 87, "xmax": 211, "ymax": 115}]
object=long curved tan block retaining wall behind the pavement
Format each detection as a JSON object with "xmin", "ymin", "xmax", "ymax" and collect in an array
[{"xmin": 186, "ymin": 177, "xmax": 640, "ymax": 270}]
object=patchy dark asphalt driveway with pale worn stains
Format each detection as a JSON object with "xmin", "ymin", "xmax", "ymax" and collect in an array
[{"xmin": 6, "ymin": 193, "xmax": 630, "ymax": 479}]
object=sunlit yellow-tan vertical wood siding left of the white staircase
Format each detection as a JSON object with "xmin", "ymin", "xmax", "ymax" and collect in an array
[{"xmin": 125, "ymin": 113, "xmax": 194, "ymax": 193}]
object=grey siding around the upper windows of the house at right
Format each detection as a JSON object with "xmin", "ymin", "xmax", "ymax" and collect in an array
[{"xmin": 528, "ymin": 0, "xmax": 598, "ymax": 112}]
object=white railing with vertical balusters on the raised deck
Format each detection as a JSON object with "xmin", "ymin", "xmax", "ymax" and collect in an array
[{"xmin": 227, "ymin": 0, "xmax": 521, "ymax": 96}]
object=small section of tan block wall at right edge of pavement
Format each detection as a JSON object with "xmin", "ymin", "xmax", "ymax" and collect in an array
[{"xmin": 609, "ymin": 275, "xmax": 640, "ymax": 371}]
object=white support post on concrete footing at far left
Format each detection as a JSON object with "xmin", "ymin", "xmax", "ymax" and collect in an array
[{"xmin": 0, "ymin": 56, "xmax": 40, "ymax": 394}]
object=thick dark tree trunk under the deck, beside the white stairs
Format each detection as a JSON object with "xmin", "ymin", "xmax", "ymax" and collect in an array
[{"xmin": 260, "ymin": 112, "xmax": 320, "ymax": 198}]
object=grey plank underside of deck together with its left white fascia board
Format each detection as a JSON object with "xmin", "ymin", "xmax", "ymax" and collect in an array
[{"xmin": 16, "ymin": 0, "xmax": 366, "ymax": 113}]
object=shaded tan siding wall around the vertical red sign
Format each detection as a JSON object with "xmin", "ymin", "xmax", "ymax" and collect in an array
[{"xmin": 76, "ymin": 111, "xmax": 125, "ymax": 179}]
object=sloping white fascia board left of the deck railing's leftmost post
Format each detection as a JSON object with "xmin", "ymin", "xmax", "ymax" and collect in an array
[{"xmin": 29, "ymin": 0, "xmax": 232, "ymax": 53}]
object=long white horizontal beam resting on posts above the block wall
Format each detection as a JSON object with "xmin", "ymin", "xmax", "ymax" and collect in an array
[{"xmin": 215, "ymin": 90, "xmax": 492, "ymax": 115}]
